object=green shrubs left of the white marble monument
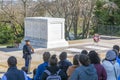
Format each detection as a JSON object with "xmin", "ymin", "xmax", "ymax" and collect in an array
[{"xmin": 0, "ymin": 23, "xmax": 23, "ymax": 44}]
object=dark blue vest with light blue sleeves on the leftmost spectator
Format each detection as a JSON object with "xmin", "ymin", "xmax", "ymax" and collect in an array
[{"xmin": 2, "ymin": 67, "xmax": 28, "ymax": 80}]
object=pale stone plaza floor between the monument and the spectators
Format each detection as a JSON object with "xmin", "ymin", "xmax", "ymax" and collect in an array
[{"xmin": 0, "ymin": 38, "xmax": 120, "ymax": 76}]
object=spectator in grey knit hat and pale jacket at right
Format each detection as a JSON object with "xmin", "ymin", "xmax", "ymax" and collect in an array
[{"xmin": 102, "ymin": 50, "xmax": 120, "ymax": 80}]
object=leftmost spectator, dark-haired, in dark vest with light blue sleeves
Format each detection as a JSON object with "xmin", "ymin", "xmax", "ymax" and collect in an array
[{"xmin": 2, "ymin": 56, "xmax": 27, "ymax": 80}]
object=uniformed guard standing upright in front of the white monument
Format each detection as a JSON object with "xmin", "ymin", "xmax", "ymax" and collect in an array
[{"xmin": 23, "ymin": 40, "xmax": 34, "ymax": 72}]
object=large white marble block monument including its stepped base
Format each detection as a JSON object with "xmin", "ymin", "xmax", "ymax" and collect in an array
[{"xmin": 19, "ymin": 17, "xmax": 68, "ymax": 48}]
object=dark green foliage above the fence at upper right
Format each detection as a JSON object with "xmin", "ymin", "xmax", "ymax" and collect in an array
[{"xmin": 94, "ymin": 0, "xmax": 120, "ymax": 25}]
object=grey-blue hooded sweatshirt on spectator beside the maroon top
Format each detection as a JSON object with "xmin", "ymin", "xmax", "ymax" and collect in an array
[{"xmin": 70, "ymin": 64, "xmax": 98, "ymax": 80}]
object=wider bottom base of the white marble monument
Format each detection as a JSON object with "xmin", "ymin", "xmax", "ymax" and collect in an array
[{"xmin": 19, "ymin": 38, "xmax": 68, "ymax": 49}]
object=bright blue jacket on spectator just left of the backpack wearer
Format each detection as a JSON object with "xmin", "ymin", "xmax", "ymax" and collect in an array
[{"xmin": 34, "ymin": 62, "xmax": 48, "ymax": 80}]
